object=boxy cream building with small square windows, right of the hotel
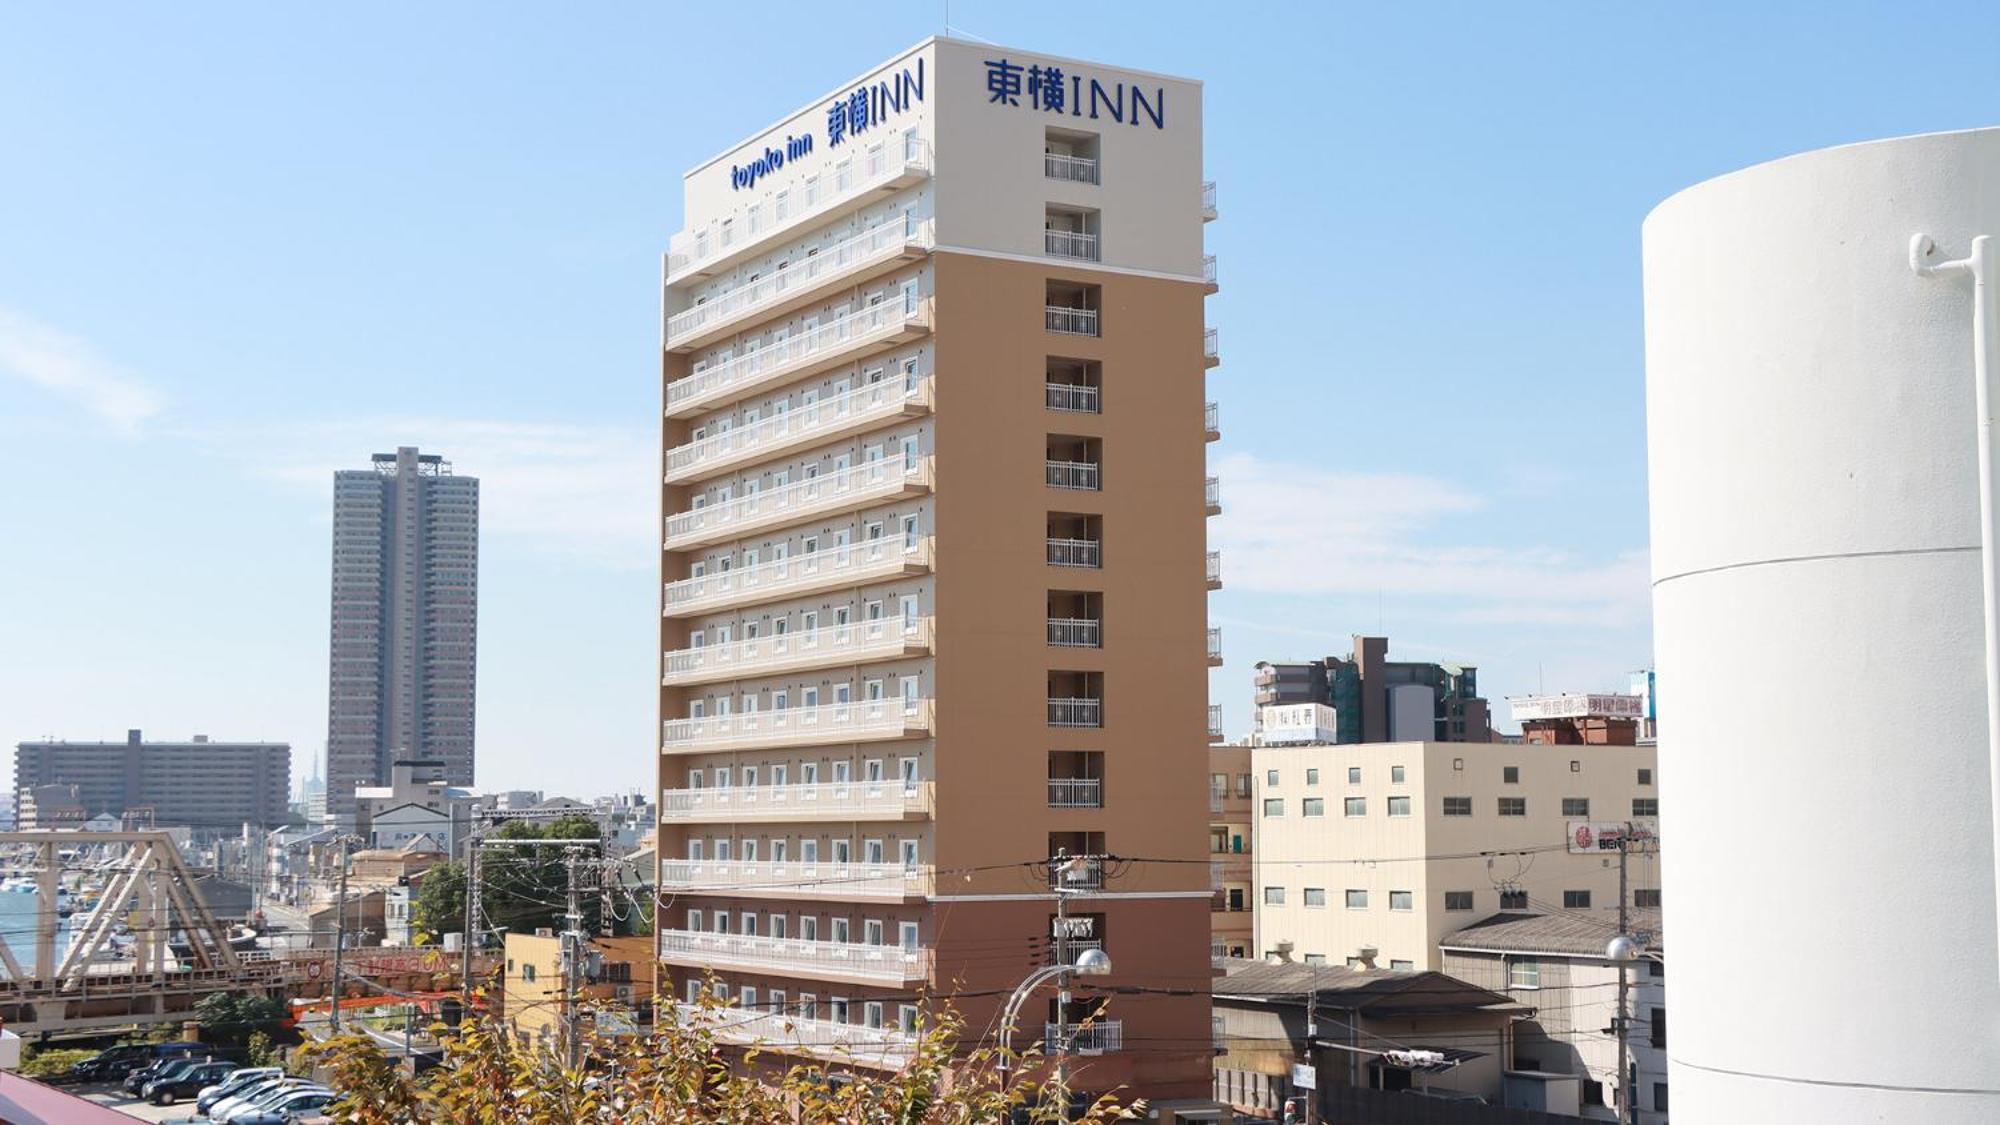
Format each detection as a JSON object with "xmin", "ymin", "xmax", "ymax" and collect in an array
[{"xmin": 1252, "ymin": 743, "xmax": 1660, "ymax": 969}]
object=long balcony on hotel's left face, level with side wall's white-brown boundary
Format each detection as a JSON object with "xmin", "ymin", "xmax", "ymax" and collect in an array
[{"xmin": 666, "ymin": 216, "xmax": 934, "ymax": 352}]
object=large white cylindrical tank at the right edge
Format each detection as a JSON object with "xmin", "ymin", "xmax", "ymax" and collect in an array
[{"xmin": 1636, "ymin": 128, "xmax": 2000, "ymax": 1125}]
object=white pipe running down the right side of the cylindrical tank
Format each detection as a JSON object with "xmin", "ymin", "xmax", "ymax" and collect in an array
[{"xmin": 1910, "ymin": 234, "xmax": 2000, "ymax": 972}]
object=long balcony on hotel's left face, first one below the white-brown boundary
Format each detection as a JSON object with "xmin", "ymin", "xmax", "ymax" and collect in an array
[{"xmin": 666, "ymin": 300, "xmax": 930, "ymax": 418}]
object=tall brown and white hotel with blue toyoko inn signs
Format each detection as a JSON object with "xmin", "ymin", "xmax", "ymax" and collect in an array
[{"xmin": 658, "ymin": 38, "xmax": 1216, "ymax": 1097}]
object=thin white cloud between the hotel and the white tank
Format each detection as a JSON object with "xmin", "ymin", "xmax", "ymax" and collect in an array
[{"xmin": 1216, "ymin": 444, "xmax": 1648, "ymax": 629}]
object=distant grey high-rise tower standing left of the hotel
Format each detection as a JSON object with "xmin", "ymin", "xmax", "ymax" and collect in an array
[{"xmin": 326, "ymin": 446, "xmax": 480, "ymax": 819}]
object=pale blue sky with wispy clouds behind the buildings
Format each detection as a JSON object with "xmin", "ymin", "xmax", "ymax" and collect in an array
[{"xmin": 0, "ymin": 0, "xmax": 2000, "ymax": 795}]
